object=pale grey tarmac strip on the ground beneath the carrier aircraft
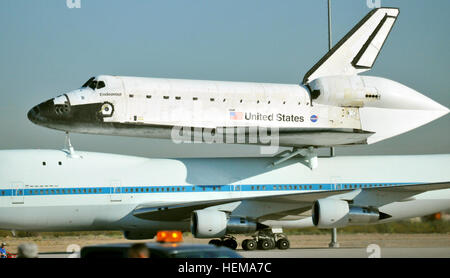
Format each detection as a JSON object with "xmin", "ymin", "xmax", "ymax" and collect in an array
[{"xmin": 39, "ymin": 247, "xmax": 450, "ymax": 258}]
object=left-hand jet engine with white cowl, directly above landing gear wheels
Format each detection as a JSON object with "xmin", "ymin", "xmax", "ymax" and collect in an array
[{"xmin": 191, "ymin": 210, "xmax": 258, "ymax": 238}]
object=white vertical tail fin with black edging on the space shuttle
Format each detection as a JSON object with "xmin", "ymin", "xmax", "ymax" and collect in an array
[{"xmin": 303, "ymin": 8, "xmax": 400, "ymax": 84}]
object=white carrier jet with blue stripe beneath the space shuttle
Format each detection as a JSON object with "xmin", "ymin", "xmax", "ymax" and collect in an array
[{"xmin": 0, "ymin": 150, "xmax": 450, "ymax": 250}]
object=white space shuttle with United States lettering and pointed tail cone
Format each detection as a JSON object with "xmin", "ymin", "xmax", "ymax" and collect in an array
[{"xmin": 28, "ymin": 8, "xmax": 449, "ymax": 148}]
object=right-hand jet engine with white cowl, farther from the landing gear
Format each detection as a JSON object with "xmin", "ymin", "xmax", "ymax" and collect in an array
[{"xmin": 312, "ymin": 199, "xmax": 389, "ymax": 228}]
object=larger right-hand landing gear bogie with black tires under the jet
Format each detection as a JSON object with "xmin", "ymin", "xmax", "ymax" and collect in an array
[{"xmin": 242, "ymin": 229, "xmax": 290, "ymax": 251}]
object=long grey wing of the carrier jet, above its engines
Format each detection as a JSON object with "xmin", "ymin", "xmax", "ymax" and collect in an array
[{"xmin": 133, "ymin": 181, "xmax": 450, "ymax": 221}]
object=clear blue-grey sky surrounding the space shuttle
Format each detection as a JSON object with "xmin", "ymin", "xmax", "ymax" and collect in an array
[{"xmin": 0, "ymin": 0, "xmax": 450, "ymax": 157}]
